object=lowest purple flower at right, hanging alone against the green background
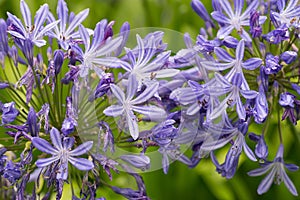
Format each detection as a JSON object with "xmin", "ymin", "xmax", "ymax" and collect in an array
[{"xmin": 248, "ymin": 144, "xmax": 299, "ymax": 196}]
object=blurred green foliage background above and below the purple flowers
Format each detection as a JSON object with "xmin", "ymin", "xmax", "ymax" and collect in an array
[{"xmin": 0, "ymin": 0, "xmax": 300, "ymax": 200}]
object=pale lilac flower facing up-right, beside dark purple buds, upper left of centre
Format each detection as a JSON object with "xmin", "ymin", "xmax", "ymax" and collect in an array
[{"xmin": 72, "ymin": 20, "xmax": 123, "ymax": 77}]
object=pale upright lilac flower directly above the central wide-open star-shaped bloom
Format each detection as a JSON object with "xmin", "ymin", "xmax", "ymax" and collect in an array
[{"xmin": 122, "ymin": 33, "xmax": 179, "ymax": 90}]
